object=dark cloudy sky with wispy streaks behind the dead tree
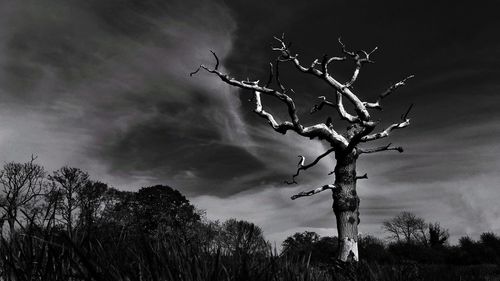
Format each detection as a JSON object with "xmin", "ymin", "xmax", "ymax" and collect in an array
[{"xmin": 0, "ymin": 0, "xmax": 500, "ymax": 245}]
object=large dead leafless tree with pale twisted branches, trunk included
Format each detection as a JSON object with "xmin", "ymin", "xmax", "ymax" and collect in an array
[{"xmin": 190, "ymin": 36, "xmax": 413, "ymax": 262}]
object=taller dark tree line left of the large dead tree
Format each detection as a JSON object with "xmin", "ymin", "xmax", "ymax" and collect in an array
[{"xmin": 0, "ymin": 157, "xmax": 270, "ymax": 254}]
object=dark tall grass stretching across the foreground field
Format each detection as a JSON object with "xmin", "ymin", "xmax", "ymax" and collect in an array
[{"xmin": 0, "ymin": 229, "xmax": 499, "ymax": 281}]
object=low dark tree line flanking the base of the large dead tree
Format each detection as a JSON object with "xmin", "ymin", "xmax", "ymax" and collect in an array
[{"xmin": 282, "ymin": 211, "xmax": 500, "ymax": 266}]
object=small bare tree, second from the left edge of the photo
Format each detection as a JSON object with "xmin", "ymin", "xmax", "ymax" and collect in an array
[{"xmin": 49, "ymin": 167, "xmax": 89, "ymax": 238}]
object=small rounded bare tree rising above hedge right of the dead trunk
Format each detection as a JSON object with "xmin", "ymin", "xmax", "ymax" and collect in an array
[{"xmin": 382, "ymin": 212, "xmax": 427, "ymax": 244}]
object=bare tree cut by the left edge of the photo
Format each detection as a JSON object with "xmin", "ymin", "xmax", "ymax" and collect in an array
[{"xmin": 0, "ymin": 156, "xmax": 45, "ymax": 237}]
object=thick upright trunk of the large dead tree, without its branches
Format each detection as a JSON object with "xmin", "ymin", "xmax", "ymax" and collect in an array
[{"xmin": 333, "ymin": 150, "xmax": 359, "ymax": 262}]
